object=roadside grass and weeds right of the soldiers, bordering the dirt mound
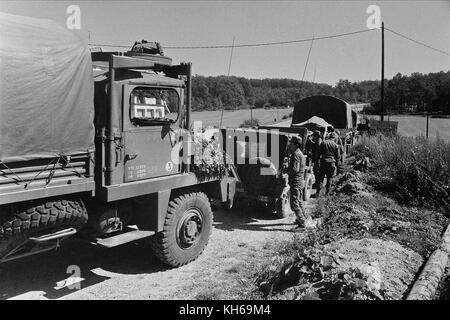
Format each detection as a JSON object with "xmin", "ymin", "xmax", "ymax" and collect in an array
[{"xmin": 246, "ymin": 135, "xmax": 450, "ymax": 298}]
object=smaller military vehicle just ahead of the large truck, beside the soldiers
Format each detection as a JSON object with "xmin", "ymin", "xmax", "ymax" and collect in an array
[{"xmin": 215, "ymin": 126, "xmax": 314, "ymax": 218}]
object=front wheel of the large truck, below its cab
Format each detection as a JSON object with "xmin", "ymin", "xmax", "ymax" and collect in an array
[{"xmin": 150, "ymin": 192, "xmax": 213, "ymax": 267}]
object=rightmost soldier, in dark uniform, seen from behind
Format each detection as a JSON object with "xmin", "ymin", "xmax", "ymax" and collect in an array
[{"xmin": 316, "ymin": 133, "xmax": 340, "ymax": 198}]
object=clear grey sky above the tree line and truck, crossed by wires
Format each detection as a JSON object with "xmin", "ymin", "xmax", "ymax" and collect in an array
[{"xmin": 0, "ymin": 0, "xmax": 450, "ymax": 84}]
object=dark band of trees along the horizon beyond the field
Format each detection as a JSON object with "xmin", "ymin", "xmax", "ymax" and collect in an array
[{"xmin": 192, "ymin": 71, "xmax": 450, "ymax": 114}]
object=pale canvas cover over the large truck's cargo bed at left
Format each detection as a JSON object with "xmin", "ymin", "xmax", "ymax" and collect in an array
[{"xmin": 0, "ymin": 13, "xmax": 95, "ymax": 162}]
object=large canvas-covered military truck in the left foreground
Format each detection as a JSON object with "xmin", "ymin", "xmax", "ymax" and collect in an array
[{"xmin": 0, "ymin": 14, "xmax": 234, "ymax": 267}]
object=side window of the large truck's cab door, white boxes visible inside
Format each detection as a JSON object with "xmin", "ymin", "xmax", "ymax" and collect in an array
[{"xmin": 130, "ymin": 87, "xmax": 180, "ymax": 126}]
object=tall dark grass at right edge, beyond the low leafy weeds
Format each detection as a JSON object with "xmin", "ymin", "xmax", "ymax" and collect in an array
[{"xmin": 352, "ymin": 135, "xmax": 450, "ymax": 209}]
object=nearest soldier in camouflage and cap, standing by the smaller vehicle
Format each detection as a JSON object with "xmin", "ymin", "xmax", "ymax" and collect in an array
[{"xmin": 287, "ymin": 136, "xmax": 309, "ymax": 227}]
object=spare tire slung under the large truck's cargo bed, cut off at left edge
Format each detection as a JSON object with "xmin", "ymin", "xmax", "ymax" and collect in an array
[{"xmin": 0, "ymin": 199, "xmax": 88, "ymax": 258}]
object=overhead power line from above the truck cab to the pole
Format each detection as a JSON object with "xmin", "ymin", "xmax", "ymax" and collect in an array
[{"xmin": 89, "ymin": 29, "xmax": 376, "ymax": 50}]
